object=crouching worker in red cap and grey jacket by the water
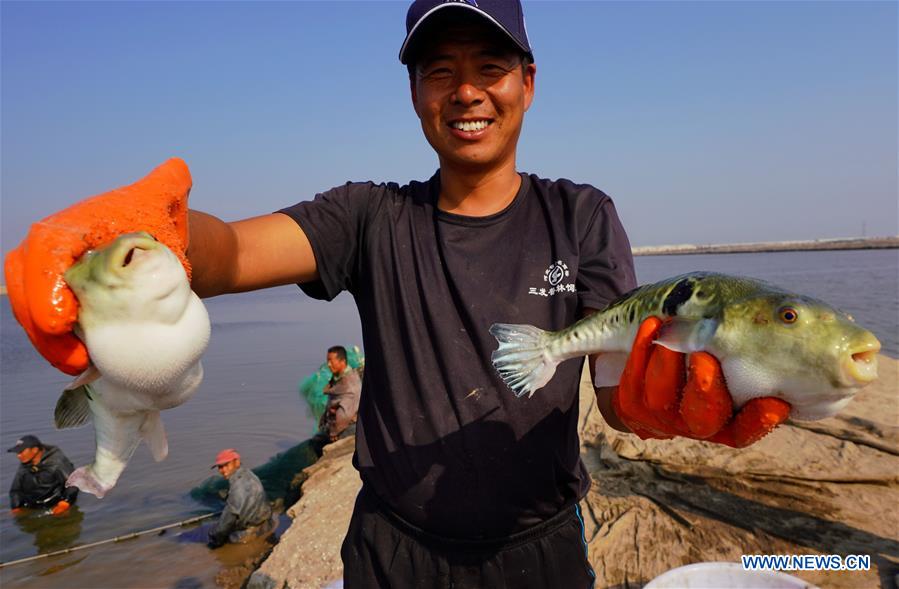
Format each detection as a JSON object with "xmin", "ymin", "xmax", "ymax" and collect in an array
[{"xmin": 209, "ymin": 448, "xmax": 275, "ymax": 548}]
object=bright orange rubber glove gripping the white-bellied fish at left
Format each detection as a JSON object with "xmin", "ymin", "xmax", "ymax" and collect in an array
[{"xmin": 5, "ymin": 158, "xmax": 191, "ymax": 375}]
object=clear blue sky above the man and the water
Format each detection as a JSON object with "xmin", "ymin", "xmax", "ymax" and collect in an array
[{"xmin": 0, "ymin": 0, "xmax": 899, "ymax": 253}]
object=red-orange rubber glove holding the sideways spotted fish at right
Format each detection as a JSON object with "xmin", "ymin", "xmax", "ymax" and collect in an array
[{"xmin": 612, "ymin": 317, "xmax": 790, "ymax": 448}]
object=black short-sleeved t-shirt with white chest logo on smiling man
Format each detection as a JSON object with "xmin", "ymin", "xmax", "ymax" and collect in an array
[{"xmin": 281, "ymin": 173, "xmax": 635, "ymax": 538}]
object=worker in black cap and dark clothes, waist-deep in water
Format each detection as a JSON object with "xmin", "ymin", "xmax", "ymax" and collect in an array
[{"xmin": 7, "ymin": 434, "xmax": 78, "ymax": 515}]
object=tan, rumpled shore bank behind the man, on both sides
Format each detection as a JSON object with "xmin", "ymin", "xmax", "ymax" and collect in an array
[{"xmin": 246, "ymin": 356, "xmax": 899, "ymax": 589}]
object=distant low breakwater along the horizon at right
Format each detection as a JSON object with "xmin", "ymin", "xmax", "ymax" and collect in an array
[{"xmin": 631, "ymin": 236, "xmax": 899, "ymax": 256}]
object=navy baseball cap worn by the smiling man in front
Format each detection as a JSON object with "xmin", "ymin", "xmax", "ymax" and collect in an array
[{"xmin": 400, "ymin": 0, "xmax": 534, "ymax": 65}]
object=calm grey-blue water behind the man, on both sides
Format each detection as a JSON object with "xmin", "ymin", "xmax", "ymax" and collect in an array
[{"xmin": 0, "ymin": 250, "xmax": 899, "ymax": 589}]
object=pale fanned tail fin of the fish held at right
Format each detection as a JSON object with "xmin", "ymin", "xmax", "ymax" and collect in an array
[{"xmin": 490, "ymin": 323, "xmax": 559, "ymax": 397}]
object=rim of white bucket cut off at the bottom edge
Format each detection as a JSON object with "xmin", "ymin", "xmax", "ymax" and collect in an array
[{"xmin": 643, "ymin": 562, "xmax": 818, "ymax": 589}]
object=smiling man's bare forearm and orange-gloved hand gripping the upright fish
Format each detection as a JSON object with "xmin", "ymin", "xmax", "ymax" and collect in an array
[{"xmin": 5, "ymin": 158, "xmax": 317, "ymax": 375}]
